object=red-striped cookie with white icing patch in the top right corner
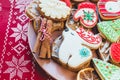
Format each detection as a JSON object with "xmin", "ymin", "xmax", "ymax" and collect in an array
[{"xmin": 98, "ymin": 0, "xmax": 120, "ymax": 19}]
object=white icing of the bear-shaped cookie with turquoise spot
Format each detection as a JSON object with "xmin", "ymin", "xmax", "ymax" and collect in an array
[{"xmin": 58, "ymin": 28, "xmax": 92, "ymax": 69}]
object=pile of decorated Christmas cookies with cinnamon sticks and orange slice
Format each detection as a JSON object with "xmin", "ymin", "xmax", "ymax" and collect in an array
[{"xmin": 26, "ymin": 0, "xmax": 120, "ymax": 80}]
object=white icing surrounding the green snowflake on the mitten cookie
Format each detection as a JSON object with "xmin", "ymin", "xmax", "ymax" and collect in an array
[{"xmin": 74, "ymin": 8, "xmax": 97, "ymax": 25}]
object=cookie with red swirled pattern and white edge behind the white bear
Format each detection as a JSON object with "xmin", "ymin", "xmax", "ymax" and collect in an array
[{"xmin": 76, "ymin": 27, "xmax": 102, "ymax": 49}]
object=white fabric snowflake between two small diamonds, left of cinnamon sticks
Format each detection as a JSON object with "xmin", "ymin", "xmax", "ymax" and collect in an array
[{"xmin": 10, "ymin": 23, "xmax": 28, "ymax": 42}]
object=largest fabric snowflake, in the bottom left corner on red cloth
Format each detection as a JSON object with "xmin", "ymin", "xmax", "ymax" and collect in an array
[{"xmin": 4, "ymin": 55, "xmax": 30, "ymax": 80}]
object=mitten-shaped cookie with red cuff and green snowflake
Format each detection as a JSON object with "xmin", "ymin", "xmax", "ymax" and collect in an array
[{"xmin": 74, "ymin": 2, "xmax": 98, "ymax": 28}]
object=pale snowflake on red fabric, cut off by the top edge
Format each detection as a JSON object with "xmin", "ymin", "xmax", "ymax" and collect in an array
[{"xmin": 15, "ymin": 0, "xmax": 32, "ymax": 13}]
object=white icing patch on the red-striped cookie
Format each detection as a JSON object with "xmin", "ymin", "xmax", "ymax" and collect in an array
[{"xmin": 105, "ymin": 1, "xmax": 120, "ymax": 13}]
